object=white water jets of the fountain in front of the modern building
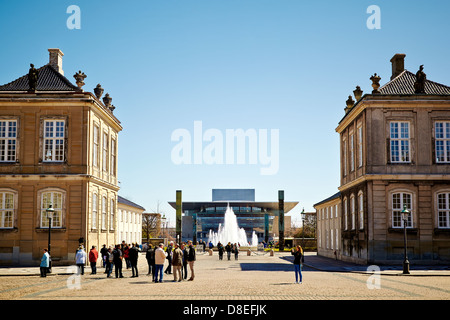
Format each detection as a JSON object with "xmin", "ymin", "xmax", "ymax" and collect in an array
[{"xmin": 208, "ymin": 206, "xmax": 258, "ymax": 247}]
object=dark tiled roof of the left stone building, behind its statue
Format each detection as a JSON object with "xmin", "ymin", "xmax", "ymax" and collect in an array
[{"xmin": 0, "ymin": 64, "xmax": 80, "ymax": 91}]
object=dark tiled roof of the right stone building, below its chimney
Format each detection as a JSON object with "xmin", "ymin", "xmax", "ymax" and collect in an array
[{"xmin": 379, "ymin": 70, "xmax": 450, "ymax": 95}]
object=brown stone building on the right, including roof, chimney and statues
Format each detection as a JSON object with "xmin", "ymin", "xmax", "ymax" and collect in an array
[{"xmin": 336, "ymin": 54, "xmax": 450, "ymax": 264}]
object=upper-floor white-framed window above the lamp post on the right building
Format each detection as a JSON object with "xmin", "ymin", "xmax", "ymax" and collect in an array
[{"xmin": 390, "ymin": 121, "xmax": 411, "ymax": 163}]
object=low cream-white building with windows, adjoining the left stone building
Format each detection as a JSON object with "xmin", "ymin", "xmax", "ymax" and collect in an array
[{"xmin": 116, "ymin": 196, "xmax": 145, "ymax": 244}]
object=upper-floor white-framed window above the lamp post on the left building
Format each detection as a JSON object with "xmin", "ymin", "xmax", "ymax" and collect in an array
[{"xmin": 44, "ymin": 120, "xmax": 65, "ymax": 162}]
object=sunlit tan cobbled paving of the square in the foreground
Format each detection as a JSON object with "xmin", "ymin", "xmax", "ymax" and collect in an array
[{"xmin": 0, "ymin": 253, "xmax": 450, "ymax": 301}]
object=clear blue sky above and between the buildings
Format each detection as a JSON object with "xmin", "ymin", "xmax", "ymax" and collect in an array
[{"xmin": 0, "ymin": 0, "xmax": 450, "ymax": 224}]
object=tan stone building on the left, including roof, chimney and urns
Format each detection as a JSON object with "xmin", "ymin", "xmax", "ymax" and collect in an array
[{"xmin": 0, "ymin": 49, "xmax": 122, "ymax": 265}]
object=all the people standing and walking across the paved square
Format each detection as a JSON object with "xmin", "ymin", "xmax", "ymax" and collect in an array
[{"xmin": 40, "ymin": 240, "xmax": 304, "ymax": 283}]
